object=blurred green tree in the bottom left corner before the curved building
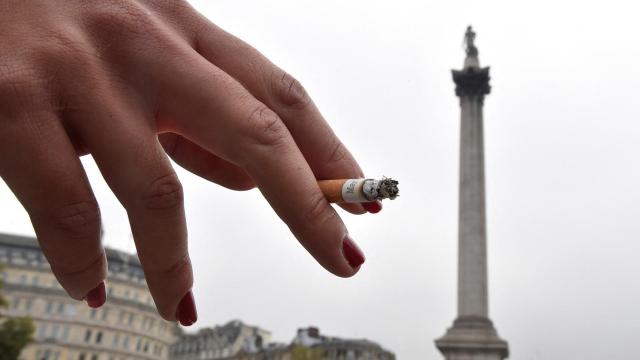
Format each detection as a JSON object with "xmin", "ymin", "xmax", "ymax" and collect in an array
[{"xmin": 0, "ymin": 266, "xmax": 35, "ymax": 360}]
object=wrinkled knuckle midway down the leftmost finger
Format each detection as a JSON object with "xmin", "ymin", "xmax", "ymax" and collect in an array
[{"xmin": 51, "ymin": 200, "xmax": 100, "ymax": 238}]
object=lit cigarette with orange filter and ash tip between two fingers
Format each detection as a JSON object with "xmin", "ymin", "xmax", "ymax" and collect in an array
[{"xmin": 318, "ymin": 178, "xmax": 399, "ymax": 203}]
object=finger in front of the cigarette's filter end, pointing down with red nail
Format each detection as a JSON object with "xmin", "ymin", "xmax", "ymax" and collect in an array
[{"xmin": 150, "ymin": 49, "xmax": 364, "ymax": 277}]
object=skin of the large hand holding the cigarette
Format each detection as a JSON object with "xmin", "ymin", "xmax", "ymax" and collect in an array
[{"xmin": 0, "ymin": 0, "xmax": 376, "ymax": 321}]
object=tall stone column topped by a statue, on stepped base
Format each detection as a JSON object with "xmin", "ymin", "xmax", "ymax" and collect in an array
[{"xmin": 435, "ymin": 26, "xmax": 509, "ymax": 360}]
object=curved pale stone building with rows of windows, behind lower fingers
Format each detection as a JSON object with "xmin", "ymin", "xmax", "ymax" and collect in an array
[{"xmin": 0, "ymin": 234, "xmax": 178, "ymax": 360}]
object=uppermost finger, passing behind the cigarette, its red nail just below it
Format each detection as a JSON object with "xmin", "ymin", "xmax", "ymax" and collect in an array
[{"xmin": 188, "ymin": 17, "xmax": 372, "ymax": 214}]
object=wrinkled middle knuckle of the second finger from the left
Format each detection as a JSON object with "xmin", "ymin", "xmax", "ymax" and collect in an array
[{"xmin": 142, "ymin": 173, "xmax": 183, "ymax": 210}]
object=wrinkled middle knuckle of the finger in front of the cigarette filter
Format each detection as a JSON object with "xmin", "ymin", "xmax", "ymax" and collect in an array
[{"xmin": 247, "ymin": 105, "xmax": 289, "ymax": 147}]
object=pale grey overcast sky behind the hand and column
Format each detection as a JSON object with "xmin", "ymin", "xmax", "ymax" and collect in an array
[{"xmin": 0, "ymin": 0, "xmax": 640, "ymax": 360}]
